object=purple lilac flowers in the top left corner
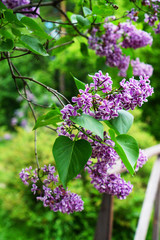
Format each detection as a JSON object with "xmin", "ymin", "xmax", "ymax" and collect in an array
[{"xmin": 2, "ymin": 0, "xmax": 39, "ymax": 17}]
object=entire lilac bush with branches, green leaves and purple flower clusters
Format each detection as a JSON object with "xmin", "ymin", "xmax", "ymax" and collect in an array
[{"xmin": 1, "ymin": 0, "xmax": 155, "ymax": 214}]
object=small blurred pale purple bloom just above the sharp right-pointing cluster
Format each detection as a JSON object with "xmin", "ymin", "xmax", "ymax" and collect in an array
[{"xmin": 131, "ymin": 58, "xmax": 153, "ymax": 77}]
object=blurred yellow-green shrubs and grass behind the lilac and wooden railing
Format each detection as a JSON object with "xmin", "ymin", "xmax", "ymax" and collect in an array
[{"xmin": 0, "ymin": 1, "xmax": 160, "ymax": 240}]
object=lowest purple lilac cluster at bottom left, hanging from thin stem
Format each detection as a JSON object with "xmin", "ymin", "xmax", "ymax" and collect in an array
[{"xmin": 19, "ymin": 165, "xmax": 83, "ymax": 214}]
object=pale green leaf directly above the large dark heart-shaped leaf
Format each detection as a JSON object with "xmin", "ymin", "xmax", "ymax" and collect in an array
[{"xmin": 70, "ymin": 113, "xmax": 104, "ymax": 139}]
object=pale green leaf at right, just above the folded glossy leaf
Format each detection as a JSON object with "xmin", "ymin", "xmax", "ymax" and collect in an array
[{"xmin": 104, "ymin": 110, "xmax": 134, "ymax": 135}]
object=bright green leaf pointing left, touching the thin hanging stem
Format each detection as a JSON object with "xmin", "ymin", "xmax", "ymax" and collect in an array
[{"xmin": 33, "ymin": 109, "xmax": 62, "ymax": 130}]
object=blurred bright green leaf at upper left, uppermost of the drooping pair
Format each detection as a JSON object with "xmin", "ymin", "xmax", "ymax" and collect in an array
[{"xmin": 21, "ymin": 17, "xmax": 52, "ymax": 39}]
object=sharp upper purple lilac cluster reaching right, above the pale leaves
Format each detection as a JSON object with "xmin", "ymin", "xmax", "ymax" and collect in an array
[{"xmin": 58, "ymin": 71, "xmax": 153, "ymax": 124}]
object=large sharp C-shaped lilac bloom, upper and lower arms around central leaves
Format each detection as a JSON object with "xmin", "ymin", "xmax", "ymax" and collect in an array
[{"xmin": 57, "ymin": 71, "xmax": 153, "ymax": 199}]
